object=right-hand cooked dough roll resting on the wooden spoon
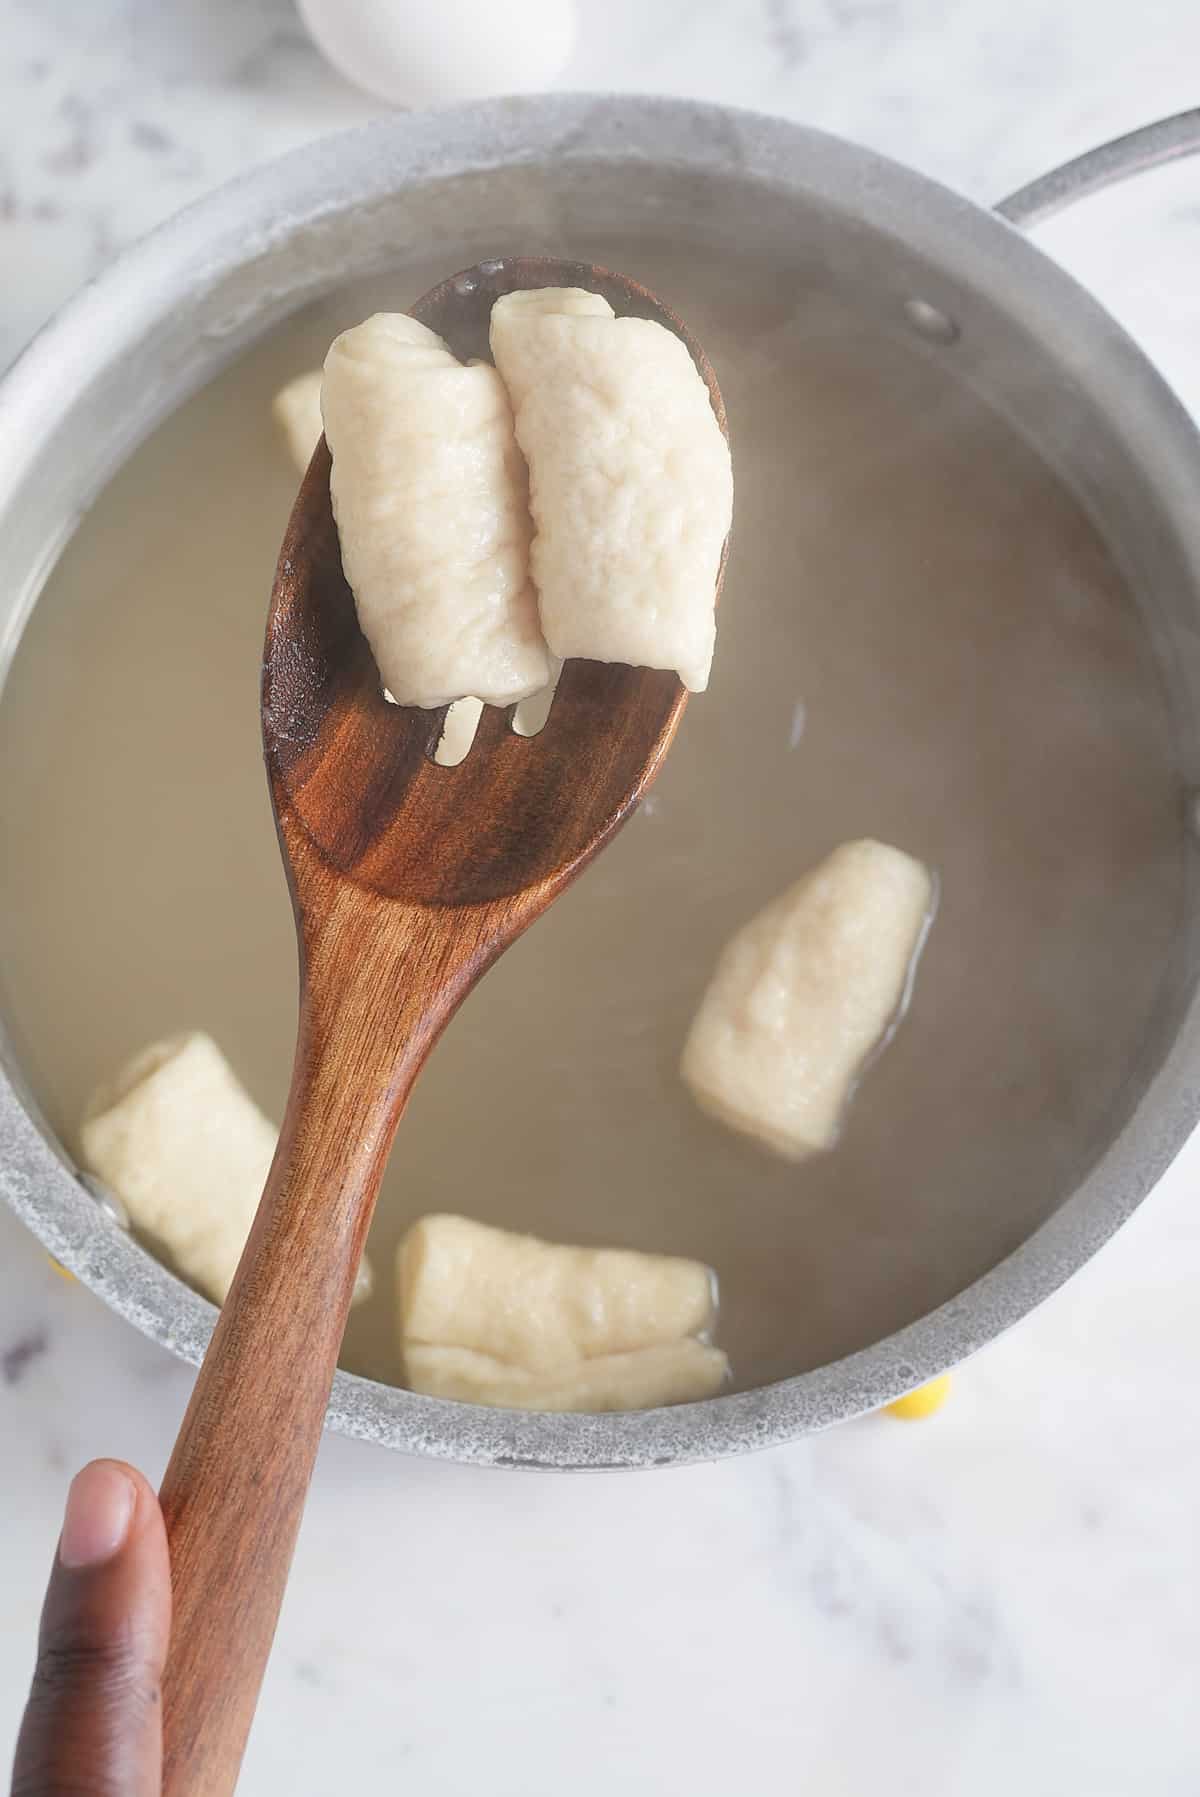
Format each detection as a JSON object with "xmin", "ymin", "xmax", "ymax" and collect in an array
[{"xmin": 490, "ymin": 288, "xmax": 733, "ymax": 692}]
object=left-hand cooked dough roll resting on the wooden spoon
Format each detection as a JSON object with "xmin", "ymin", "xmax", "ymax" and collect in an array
[{"xmin": 322, "ymin": 313, "xmax": 550, "ymax": 708}]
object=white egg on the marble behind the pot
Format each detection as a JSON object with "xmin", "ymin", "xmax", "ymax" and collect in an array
[{"xmin": 298, "ymin": 0, "xmax": 575, "ymax": 106}]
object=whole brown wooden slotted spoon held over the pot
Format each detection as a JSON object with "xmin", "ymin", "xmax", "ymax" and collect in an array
[{"xmin": 162, "ymin": 259, "xmax": 724, "ymax": 1797}]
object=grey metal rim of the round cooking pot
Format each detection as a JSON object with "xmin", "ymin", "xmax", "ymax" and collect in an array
[{"xmin": 0, "ymin": 93, "xmax": 1200, "ymax": 1468}]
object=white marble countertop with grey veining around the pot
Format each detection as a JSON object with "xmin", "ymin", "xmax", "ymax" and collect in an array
[{"xmin": 0, "ymin": 0, "xmax": 1200, "ymax": 1797}]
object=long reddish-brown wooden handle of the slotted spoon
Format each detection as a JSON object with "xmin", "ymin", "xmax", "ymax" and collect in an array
[{"xmin": 162, "ymin": 880, "xmax": 469, "ymax": 1797}]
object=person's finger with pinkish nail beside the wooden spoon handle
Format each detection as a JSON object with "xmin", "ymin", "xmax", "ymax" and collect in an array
[{"xmin": 13, "ymin": 1461, "xmax": 171, "ymax": 1797}]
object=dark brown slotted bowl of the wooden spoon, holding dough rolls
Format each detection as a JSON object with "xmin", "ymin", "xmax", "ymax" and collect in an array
[{"xmin": 262, "ymin": 257, "xmax": 726, "ymax": 906}]
